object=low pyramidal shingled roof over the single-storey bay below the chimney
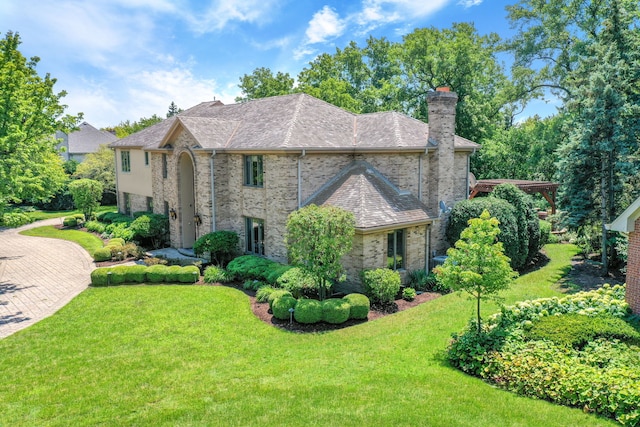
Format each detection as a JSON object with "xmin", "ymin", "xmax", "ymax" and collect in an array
[{"xmin": 304, "ymin": 161, "xmax": 436, "ymax": 232}]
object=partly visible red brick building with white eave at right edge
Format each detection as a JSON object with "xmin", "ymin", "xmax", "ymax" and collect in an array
[{"xmin": 607, "ymin": 198, "xmax": 640, "ymax": 314}]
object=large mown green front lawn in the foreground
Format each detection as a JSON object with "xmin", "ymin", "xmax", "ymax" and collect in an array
[{"xmin": 0, "ymin": 245, "xmax": 615, "ymax": 426}]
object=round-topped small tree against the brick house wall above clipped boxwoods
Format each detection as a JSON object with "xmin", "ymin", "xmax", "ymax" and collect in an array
[{"xmin": 285, "ymin": 205, "xmax": 356, "ymax": 300}]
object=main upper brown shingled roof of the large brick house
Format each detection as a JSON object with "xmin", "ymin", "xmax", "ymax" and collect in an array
[{"xmin": 111, "ymin": 93, "xmax": 479, "ymax": 152}]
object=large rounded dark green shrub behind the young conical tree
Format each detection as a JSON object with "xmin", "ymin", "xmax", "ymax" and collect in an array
[{"xmin": 446, "ymin": 197, "xmax": 526, "ymax": 270}]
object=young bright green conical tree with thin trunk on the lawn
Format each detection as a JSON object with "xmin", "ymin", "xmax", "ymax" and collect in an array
[{"xmin": 435, "ymin": 210, "xmax": 517, "ymax": 333}]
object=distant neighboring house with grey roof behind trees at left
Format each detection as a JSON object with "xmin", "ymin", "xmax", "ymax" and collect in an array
[{"xmin": 56, "ymin": 122, "xmax": 118, "ymax": 163}]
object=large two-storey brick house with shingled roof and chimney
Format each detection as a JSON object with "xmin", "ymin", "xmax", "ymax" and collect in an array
[{"xmin": 111, "ymin": 90, "xmax": 479, "ymax": 282}]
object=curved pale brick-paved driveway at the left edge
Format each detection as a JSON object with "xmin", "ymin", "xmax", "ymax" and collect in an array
[{"xmin": 0, "ymin": 218, "xmax": 95, "ymax": 338}]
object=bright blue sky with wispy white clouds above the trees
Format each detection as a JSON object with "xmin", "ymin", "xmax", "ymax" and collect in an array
[{"xmin": 0, "ymin": 0, "xmax": 552, "ymax": 127}]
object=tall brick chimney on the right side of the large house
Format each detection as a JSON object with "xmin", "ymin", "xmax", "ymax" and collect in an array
[{"xmin": 427, "ymin": 87, "xmax": 458, "ymax": 209}]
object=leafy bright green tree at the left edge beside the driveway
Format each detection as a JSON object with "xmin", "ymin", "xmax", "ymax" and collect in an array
[{"xmin": 0, "ymin": 31, "xmax": 82, "ymax": 211}]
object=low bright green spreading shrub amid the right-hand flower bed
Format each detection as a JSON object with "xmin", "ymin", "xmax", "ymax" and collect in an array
[{"xmin": 526, "ymin": 313, "xmax": 640, "ymax": 349}]
